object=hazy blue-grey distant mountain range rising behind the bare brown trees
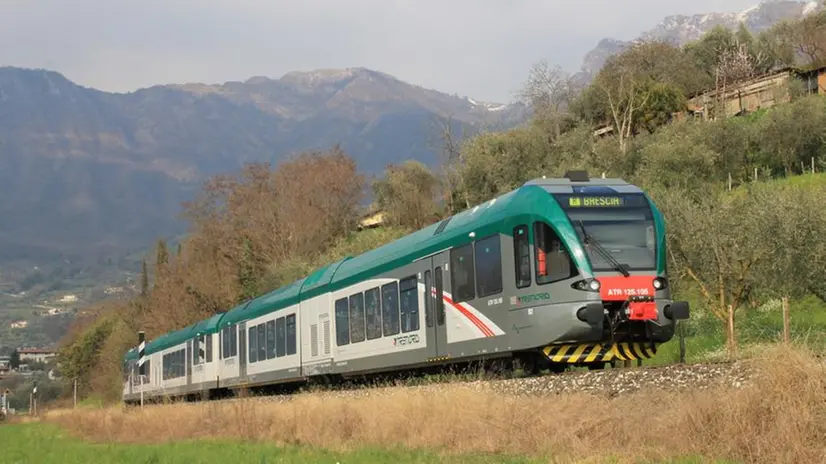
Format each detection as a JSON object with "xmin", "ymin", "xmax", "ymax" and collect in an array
[{"xmin": 0, "ymin": 67, "xmax": 521, "ymax": 266}]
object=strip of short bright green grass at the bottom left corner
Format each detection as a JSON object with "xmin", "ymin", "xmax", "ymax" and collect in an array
[{"xmin": 0, "ymin": 424, "xmax": 547, "ymax": 464}]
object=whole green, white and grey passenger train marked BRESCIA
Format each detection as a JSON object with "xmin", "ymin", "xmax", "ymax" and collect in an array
[{"xmin": 123, "ymin": 171, "xmax": 689, "ymax": 402}]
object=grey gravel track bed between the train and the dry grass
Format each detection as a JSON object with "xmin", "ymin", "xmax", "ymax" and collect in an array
[{"xmin": 248, "ymin": 362, "xmax": 752, "ymax": 402}]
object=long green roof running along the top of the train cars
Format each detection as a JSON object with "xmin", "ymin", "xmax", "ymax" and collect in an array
[{"xmin": 127, "ymin": 174, "xmax": 642, "ymax": 356}]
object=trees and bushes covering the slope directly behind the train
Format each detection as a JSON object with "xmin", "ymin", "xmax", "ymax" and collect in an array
[{"xmin": 62, "ymin": 13, "xmax": 826, "ymax": 398}]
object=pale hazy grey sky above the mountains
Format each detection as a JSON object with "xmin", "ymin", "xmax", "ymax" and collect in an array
[{"xmin": 0, "ymin": 0, "xmax": 759, "ymax": 101}]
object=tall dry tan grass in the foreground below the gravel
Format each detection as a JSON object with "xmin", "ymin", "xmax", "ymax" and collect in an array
[{"xmin": 27, "ymin": 346, "xmax": 826, "ymax": 463}]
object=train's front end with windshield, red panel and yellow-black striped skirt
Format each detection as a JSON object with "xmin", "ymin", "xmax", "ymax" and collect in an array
[{"xmin": 520, "ymin": 174, "xmax": 689, "ymax": 368}]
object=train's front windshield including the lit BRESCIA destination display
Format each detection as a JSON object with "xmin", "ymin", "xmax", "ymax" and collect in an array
[{"xmin": 554, "ymin": 193, "xmax": 657, "ymax": 271}]
